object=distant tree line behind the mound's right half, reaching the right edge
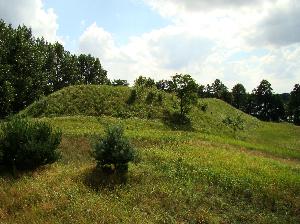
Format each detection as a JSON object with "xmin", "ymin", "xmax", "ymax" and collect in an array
[{"xmin": 134, "ymin": 74, "xmax": 300, "ymax": 125}]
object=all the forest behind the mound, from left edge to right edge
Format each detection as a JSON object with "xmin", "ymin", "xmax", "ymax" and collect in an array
[{"xmin": 0, "ymin": 20, "xmax": 300, "ymax": 125}]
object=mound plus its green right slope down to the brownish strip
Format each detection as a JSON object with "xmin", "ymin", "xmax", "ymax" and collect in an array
[{"xmin": 20, "ymin": 85, "xmax": 300, "ymax": 159}]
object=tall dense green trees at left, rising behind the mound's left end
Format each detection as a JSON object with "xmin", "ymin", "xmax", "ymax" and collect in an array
[{"xmin": 0, "ymin": 20, "xmax": 110, "ymax": 117}]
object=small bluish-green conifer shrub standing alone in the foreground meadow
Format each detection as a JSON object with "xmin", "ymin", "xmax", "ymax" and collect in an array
[{"xmin": 94, "ymin": 125, "xmax": 135, "ymax": 173}]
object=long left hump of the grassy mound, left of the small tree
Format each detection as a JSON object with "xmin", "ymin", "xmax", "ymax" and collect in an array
[{"xmin": 21, "ymin": 85, "xmax": 170, "ymax": 118}]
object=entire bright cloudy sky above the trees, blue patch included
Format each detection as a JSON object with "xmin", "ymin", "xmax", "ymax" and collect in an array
[{"xmin": 0, "ymin": 0, "xmax": 300, "ymax": 92}]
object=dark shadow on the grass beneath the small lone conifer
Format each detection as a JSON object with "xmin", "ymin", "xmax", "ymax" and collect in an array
[{"xmin": 84, "ymin": 167, "xmax": 128, "ymax": 191}]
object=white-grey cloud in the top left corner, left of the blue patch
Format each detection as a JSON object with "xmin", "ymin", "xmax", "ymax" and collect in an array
[{"xmin": 0, "ymin": 0, "xmax": 61, "ymax": 42}]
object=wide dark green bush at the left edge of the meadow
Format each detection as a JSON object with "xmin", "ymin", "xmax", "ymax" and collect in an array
[{"xmin": 0, "ymin": 118, "xmax": 61, "ymax": 170}]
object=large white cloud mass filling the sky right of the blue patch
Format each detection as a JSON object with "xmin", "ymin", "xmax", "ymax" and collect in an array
[{"xmin": 79, "ymin": 0, "xmax": 300, "ymax": 92}]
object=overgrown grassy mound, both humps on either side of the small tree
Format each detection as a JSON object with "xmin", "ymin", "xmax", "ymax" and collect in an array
[{"xmin": 21, "ymin": 85, "xmax": 259, "ymax": 135}]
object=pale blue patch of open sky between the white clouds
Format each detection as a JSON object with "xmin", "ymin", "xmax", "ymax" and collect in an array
[{"xmin": 44, "ymin": 0, "xmax": 169, "ymax": 50}]
